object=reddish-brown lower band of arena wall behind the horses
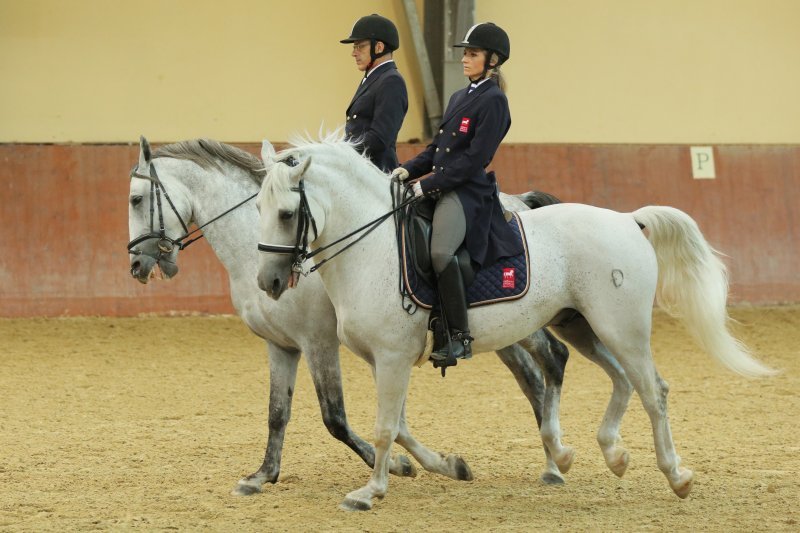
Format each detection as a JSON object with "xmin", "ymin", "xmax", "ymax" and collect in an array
[{"xmin": 0, "ymin": 144, "xmax": 800, "ymax": 317}]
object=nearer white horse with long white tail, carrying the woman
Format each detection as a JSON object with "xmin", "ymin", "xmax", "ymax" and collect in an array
[{"xmin": 257, "ymin": 136, "xmax": 773, "ymax": 510}]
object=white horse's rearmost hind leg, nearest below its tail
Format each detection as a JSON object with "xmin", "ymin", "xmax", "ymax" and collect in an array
[{"xmin": 589, "ymin": 314, "xmax": 694, "ymax": 498}]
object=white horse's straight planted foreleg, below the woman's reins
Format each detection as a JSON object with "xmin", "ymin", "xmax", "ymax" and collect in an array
[{"xmin": 340, "ymin": 356, "xmax": 413, "ymax": 511}]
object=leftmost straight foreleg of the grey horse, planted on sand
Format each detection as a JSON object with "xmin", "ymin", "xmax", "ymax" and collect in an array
[{"xmin": 232, "ymin": 342, "xmax": 300, "ymax": 496}]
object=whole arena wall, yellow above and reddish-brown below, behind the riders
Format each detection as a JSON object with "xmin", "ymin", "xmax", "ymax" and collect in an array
[{"xmin": 0, "ymin": 0, "xmax": 800, "ymax": 316}]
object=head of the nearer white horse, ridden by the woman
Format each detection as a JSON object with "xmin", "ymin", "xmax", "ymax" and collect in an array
[{"xmin": 256, "ymin": 150, "xmax": 325, "ymax": 300}]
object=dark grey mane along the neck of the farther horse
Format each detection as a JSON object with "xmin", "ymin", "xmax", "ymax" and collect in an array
[{"xmin": 153, "ymin": 139, "xmax": 266, "ymax": 185}]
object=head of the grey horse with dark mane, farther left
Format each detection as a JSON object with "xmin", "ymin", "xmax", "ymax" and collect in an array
[{"xmin": 128, "ymin": 136, "xmax": 187, "ymax": 283}]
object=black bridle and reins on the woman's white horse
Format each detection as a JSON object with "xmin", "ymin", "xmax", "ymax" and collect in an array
[{"xmin": 258, "ymin": 157, "xmax": 419, "ymax": 276}]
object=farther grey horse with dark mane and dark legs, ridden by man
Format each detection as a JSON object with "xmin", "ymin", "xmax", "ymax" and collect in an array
[{"xmin": 129, "ymin": 138, "xmax": 573, "ymax": 495}]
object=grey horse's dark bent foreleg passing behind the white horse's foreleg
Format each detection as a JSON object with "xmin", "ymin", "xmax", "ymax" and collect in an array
[{"xmin": 306, "ymin": 342, "xmax": 417, "ymax": 477}]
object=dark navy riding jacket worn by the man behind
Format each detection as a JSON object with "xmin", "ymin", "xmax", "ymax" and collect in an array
[{"xmin": 345, "ymin": 62, "xmax": 408, "ymax": 173}]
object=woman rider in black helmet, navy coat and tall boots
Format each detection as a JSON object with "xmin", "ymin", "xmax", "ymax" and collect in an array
[{"xmin": 392, "ymin": 22, "xmax": 523, "ymax": 361}]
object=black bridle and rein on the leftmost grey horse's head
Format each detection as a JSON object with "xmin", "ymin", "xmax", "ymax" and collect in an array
[{"xmin": 128, "ymin": 162, "xmax": 258, "ymax": 260}]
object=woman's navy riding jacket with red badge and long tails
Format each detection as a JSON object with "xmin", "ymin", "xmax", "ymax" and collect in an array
[{"xmin": 403, "ymin": 79, "xmax": 524, "ymax": 267}]
